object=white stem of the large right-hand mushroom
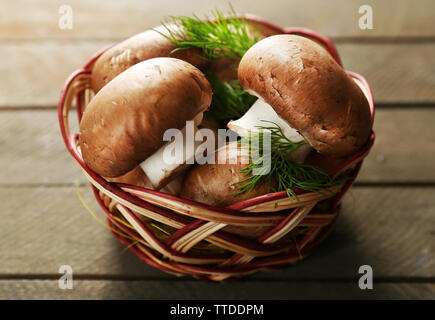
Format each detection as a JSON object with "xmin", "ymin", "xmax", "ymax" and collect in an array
[{"xmin": 227, "ymin": 99, "xmax": 312, "ymax": 163}]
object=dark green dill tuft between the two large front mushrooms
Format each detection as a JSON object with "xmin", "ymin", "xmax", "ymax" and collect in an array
[{"xmin": 205, "ymin": 71, "xmax": 257, "ymax": 122}]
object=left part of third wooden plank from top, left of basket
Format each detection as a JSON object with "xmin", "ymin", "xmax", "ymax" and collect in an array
[{"xmin": 0, "ymin": 110, "xmax": 86, "ymax": 184}]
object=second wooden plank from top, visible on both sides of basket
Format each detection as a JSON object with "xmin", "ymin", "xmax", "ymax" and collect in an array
[{"xmin": 0, "ymin": 40, "xmax": 435, "ymax": 108}]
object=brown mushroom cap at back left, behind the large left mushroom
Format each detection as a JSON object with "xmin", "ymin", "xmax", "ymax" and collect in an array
[{"xmin": 91, "ymin": 26, "xmax": 208, "ymax": 92}]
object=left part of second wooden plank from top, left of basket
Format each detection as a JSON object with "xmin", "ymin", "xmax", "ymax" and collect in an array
[{"xmin": 0, "ymin": 41, "xmax": 110, "ymax": 107}]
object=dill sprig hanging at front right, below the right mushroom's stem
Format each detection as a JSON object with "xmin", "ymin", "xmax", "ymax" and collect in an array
[{"xmin": 233, "ymin": 121, "xmax": 343, "ymax": 201}]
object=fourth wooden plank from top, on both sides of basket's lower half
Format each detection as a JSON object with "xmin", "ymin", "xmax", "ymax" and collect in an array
[{"xmin": 0, "ymin": 187, "xmax": 435, "ymax": 281}]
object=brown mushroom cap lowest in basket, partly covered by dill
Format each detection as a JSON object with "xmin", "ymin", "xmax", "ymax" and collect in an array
[{"xmin": 180, "ymin": 142, "xmax": 273, "ymax": 207}]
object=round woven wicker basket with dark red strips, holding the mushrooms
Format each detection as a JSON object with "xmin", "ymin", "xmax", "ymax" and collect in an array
[{"xmin": 58, "ymin": 16, "xmax": 375, "ymax": 281}]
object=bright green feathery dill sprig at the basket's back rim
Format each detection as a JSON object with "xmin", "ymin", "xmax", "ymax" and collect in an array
[{"xmin": 155, "ymin": 5, "xmax": 259, "ymax": 60}]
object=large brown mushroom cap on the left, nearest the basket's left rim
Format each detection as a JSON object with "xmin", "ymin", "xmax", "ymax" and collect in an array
[{"xmin": 79, "ymin": 58, "xmax": 212, "ymax": 177}]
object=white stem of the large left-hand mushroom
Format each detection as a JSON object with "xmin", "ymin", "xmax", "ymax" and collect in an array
[{"xmin": 140, "ymin": 113, "xmax": 203, "ymax": 189}]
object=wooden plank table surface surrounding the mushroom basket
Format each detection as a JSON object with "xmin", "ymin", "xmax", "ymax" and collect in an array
[{"xmin": 0, "ymin": 0, "xmax": 435, "ymax": 299}]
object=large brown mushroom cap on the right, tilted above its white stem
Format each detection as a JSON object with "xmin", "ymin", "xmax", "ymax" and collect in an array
[{"xmin": 238, "ymin": 35, "xmax": 371, "ymax": 157}]
